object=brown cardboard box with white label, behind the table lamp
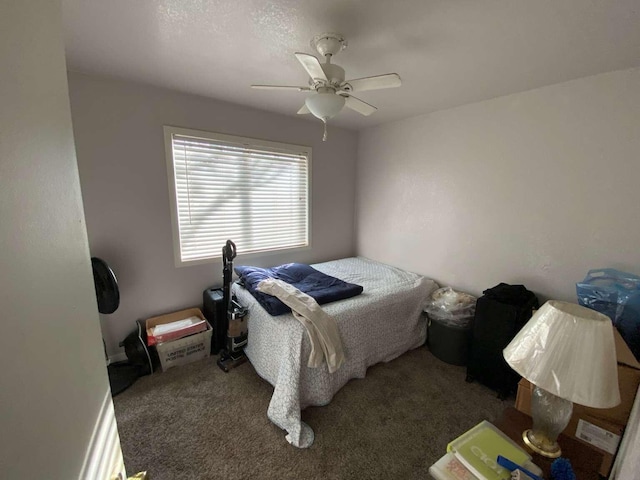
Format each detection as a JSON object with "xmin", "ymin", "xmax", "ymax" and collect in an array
[{"xmin": 516, "ymin": 328, "xmax": 640, "ymax": 477}]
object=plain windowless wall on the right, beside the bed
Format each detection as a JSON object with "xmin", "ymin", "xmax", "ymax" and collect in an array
[{"xmin": 357, "ymin": 69, "xmax": 640, "ymax": 301}]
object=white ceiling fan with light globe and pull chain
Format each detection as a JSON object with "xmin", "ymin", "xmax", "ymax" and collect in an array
[{"xmin": 251, "ymin": 33, "xmax": 402, "ymax": 141}]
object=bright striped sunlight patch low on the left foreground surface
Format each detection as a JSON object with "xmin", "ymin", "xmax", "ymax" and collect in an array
[{"xmin": 78, "ymin": 389, "xmax": 127, "ymax": 480}]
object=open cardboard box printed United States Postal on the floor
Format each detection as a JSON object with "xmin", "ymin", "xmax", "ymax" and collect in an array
[{"xmin": 145, "ymin": 308, "xmax": 212, "ymax": 372}]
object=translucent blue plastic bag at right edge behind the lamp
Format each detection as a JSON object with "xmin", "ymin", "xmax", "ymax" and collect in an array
[{"xmin": 576, "ymin": 268, "xmax": 640, "ymax": 358}]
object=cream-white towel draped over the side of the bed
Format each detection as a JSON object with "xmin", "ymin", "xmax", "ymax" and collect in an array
[{"xmin": 257, "ymin": 278, "xmax": 344, "ymax": 373}]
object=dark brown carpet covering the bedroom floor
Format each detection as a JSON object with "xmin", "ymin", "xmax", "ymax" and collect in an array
[{"xmin": 114, "ymin": 347, "xmax": 513, "ymax": 480}]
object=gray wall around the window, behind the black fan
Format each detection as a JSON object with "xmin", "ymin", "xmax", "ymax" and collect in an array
[{"xmin": 69, "ymin": 72, "xmax": 357, "ymax": 354}]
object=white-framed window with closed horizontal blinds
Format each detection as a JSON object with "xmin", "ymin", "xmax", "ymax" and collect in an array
[{"xmin": 164, "ymin": 127, "xmax": 311, "ymax": 265}]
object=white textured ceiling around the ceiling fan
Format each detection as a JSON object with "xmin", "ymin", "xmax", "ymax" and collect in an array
[{"xmin": 63, "ymin": 0, "xmax": 640, "ymax": 129}]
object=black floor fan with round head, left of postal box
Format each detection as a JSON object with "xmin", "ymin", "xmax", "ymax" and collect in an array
[{"xmin": 91, "ymin": 257, "xmax": 139, "ymax": 396}]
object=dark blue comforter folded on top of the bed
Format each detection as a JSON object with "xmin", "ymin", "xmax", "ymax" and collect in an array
[{"xmin": 234, "ymin": 263, "xmax": 362, "ymax": 316}]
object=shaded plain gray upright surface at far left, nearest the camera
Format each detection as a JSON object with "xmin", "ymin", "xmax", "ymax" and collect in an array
[{"xmin": 0, "ymin": 1, "xmax": 115, "ymax": 479}]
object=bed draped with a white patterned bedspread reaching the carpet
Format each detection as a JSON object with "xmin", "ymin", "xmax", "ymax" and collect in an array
[{"xmin": 233, "ymin": 257, "xmax": 438, "ymax": 448}]
